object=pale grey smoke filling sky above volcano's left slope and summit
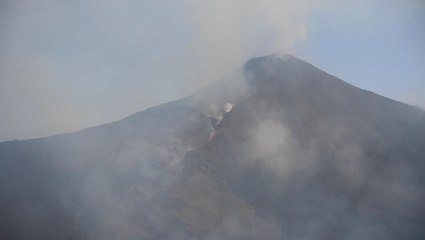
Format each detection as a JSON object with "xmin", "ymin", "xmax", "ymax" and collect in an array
[{"xmin": 0, "ymin": 0, "xmax": 324, "ymax": 141}]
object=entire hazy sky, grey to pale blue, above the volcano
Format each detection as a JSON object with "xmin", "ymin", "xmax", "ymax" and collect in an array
[{"xmin": 0, "ymin": 0, "xmax": 425, "ymax": 141}]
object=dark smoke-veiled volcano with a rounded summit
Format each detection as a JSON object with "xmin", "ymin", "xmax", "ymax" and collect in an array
[{"xmin": 0, "ymin": 55, "xmax": 425, "ymax": 240}]
